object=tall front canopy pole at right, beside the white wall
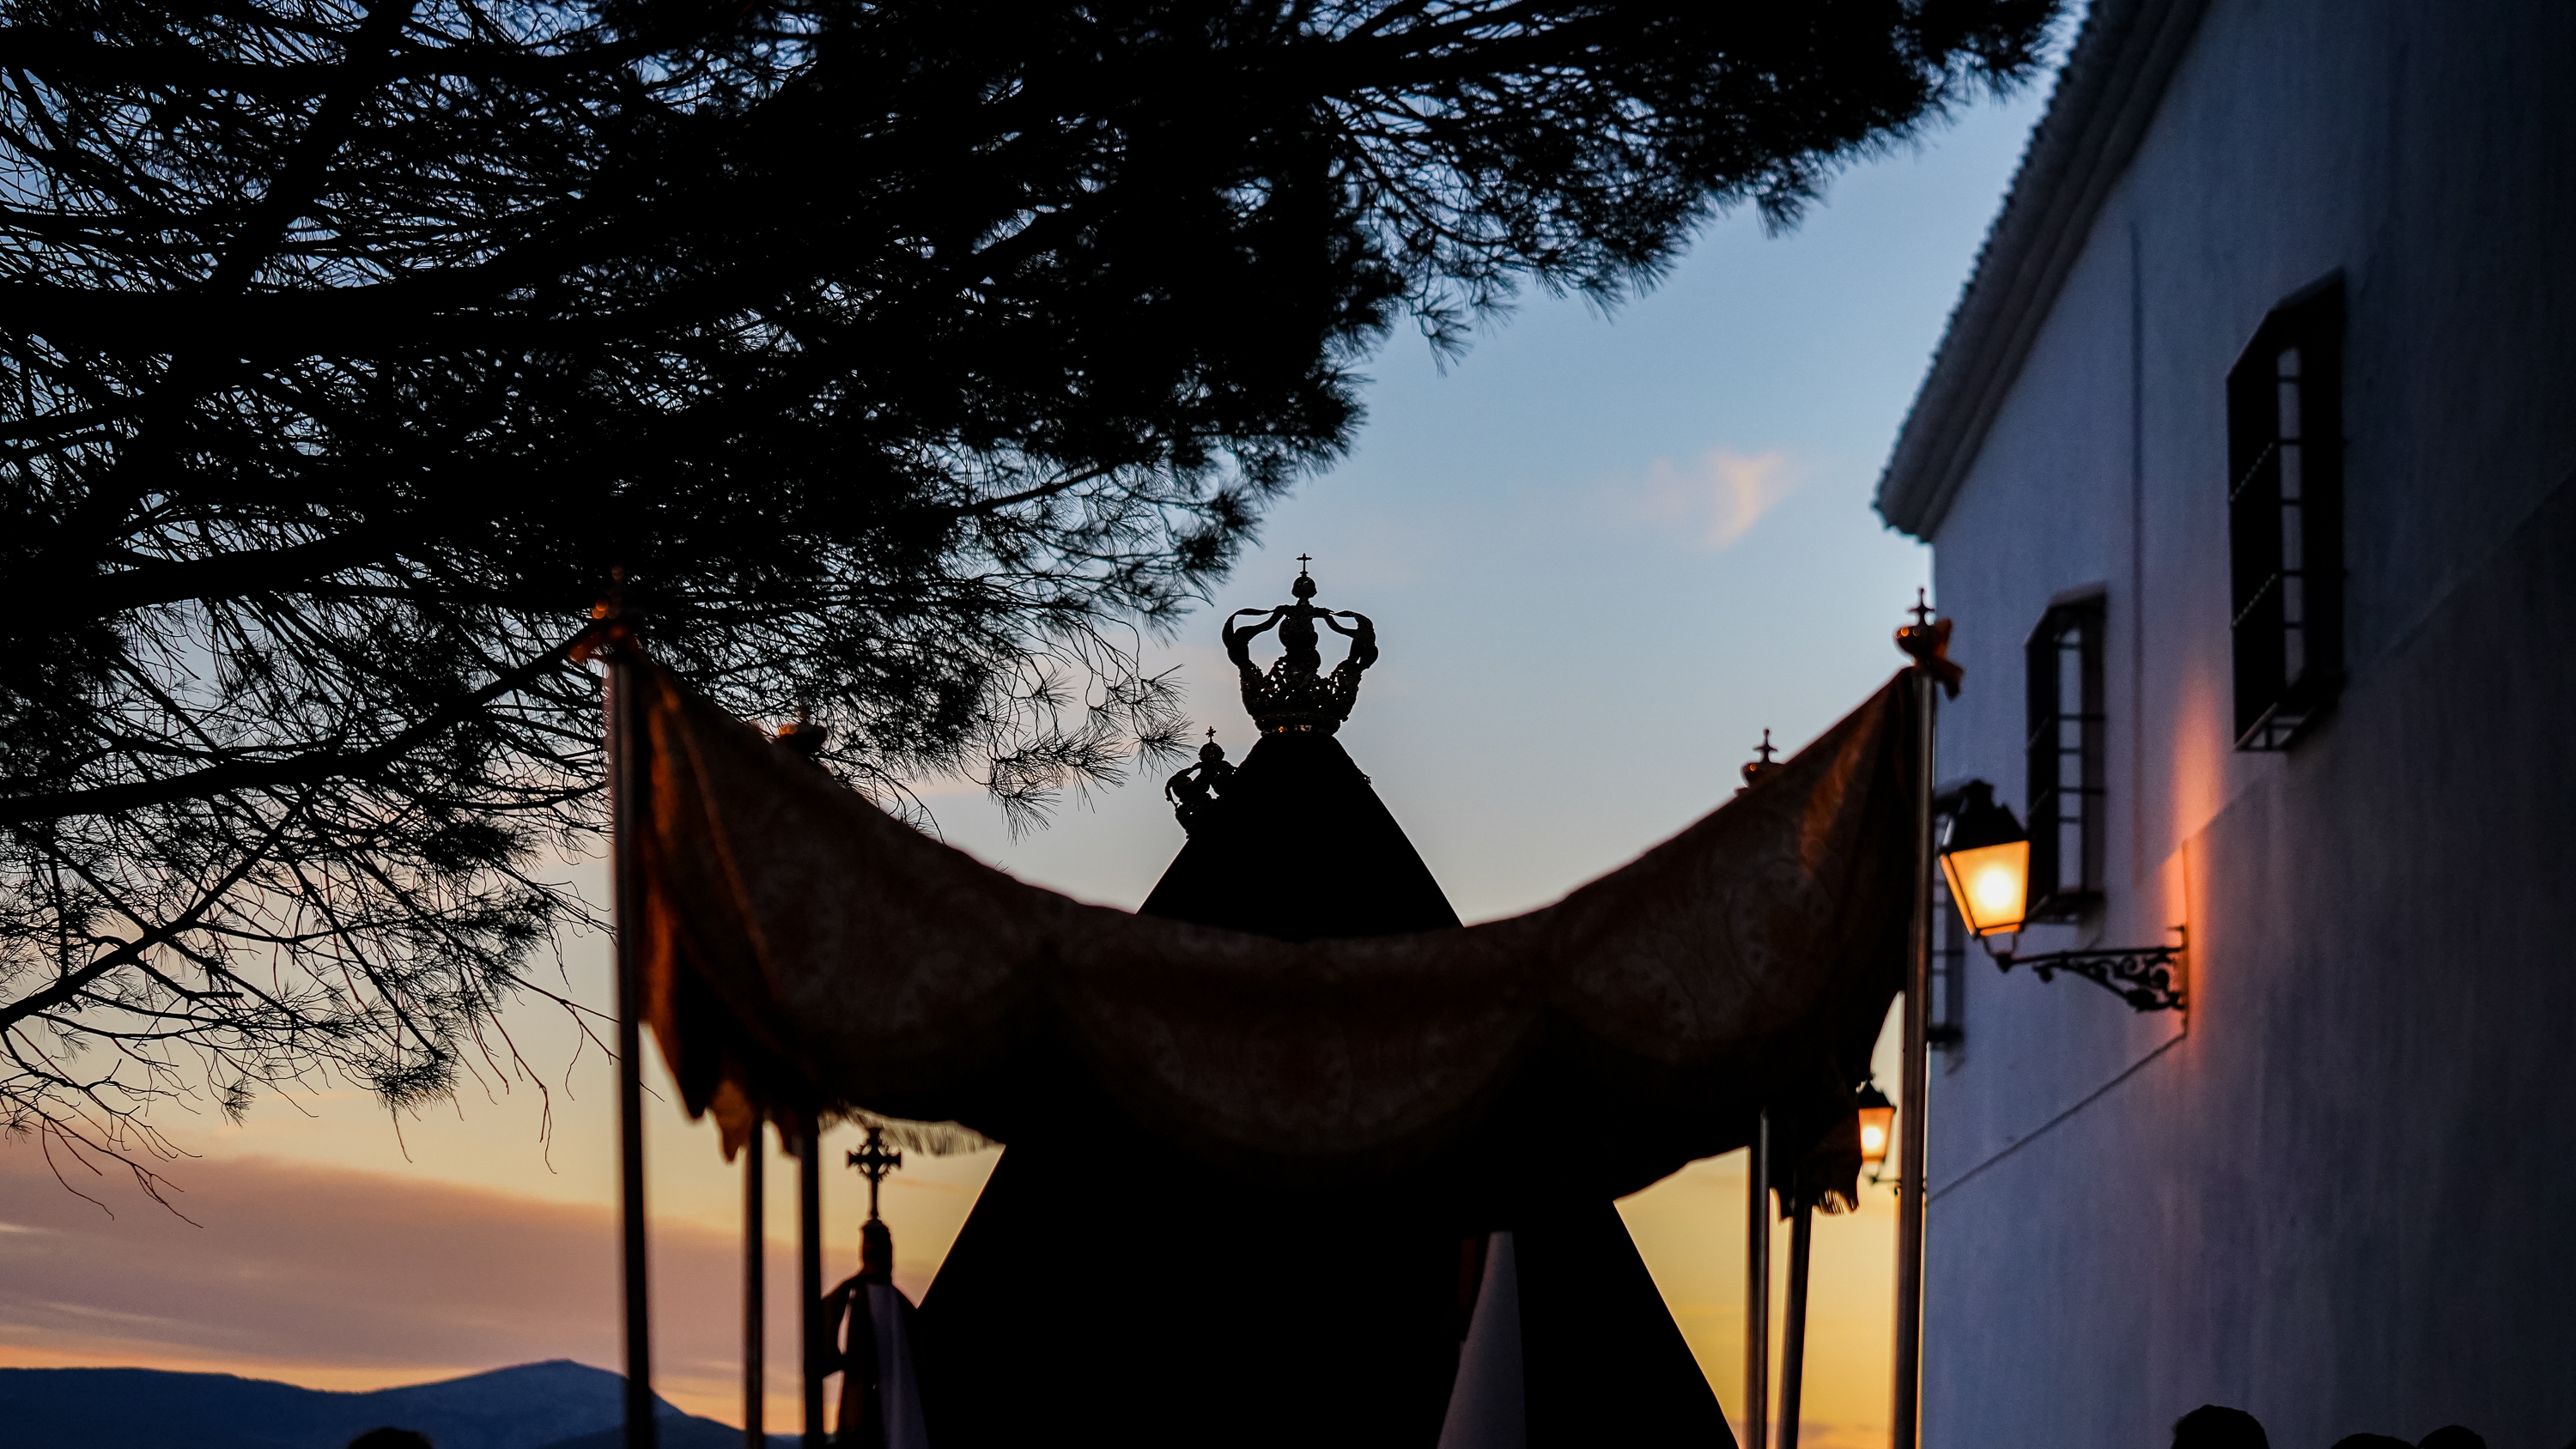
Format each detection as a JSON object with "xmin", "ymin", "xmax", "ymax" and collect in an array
[{"xmin": 1891, "ymin": 664, "xmax": 1935, "ymax": 1449}]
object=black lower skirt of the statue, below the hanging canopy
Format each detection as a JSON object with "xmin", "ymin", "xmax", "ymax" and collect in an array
[{"xmin": 920, "ymin": 1168, "xmax": 1734, "ymax": 1449}]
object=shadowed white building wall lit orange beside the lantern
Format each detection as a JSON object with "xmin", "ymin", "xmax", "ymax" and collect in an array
[{"xmin": 1924, "ymin": 0, "xmax": 2576, "ymax": 1449}]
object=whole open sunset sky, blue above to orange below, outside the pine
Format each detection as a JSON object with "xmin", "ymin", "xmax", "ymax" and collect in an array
[{"xmin": 0, "ymin": 45, "xmax": 2045, "ymax": 1449}]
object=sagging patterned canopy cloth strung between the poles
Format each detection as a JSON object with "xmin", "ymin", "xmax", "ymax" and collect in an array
[{"xmin": 616, "ymin": 644, "xmax": 1917, "ymax": 1204}]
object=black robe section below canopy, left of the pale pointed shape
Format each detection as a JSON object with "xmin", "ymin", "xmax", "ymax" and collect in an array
[{"xmin": 922, "ymin": 1148, "xmax": 1473, "ymax": 1449}]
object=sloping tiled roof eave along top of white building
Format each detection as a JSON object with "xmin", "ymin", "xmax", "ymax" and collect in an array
[{"xmin": 1878, "ymin": 0, "xmax": 2210, "ymax": 538}]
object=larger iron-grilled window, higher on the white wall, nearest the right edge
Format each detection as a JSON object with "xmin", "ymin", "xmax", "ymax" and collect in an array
[{"xmin": 2228, "ymin": 281, "xmax": 2344, "ymax": 749}]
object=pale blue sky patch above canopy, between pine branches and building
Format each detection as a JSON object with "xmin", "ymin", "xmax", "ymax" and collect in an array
[{"xmin": 930, "ymin": 79, "xmax": 2038, "ymax": 919}]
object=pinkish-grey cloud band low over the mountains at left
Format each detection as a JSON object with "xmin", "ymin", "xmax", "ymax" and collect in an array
[{"xmin": 0, "ymin": 1150, "xmax": 783, "ymax": 1421}]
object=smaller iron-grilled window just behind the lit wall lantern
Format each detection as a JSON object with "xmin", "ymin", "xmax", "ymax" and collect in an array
[{"xmin": 2022, "ymin": 595, "xmax": 2110, "ymax": 921}]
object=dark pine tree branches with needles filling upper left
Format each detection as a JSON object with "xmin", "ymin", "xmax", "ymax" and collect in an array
[{"xmin": 0, "ymin": 0, "xmax": 2053, "ymax": 1171}]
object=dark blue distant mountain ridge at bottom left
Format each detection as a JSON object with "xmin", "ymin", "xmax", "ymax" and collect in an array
[{"xmin": 0, "ymin": 1359, "xmax": 788, "ymax": 1449}]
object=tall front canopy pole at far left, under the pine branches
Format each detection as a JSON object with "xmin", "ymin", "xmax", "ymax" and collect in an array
[{"xmin": 608, "ymin": 641, "xmax": 654, "ymax": 1449}]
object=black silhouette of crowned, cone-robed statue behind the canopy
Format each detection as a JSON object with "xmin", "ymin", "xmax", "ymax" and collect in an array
[{"xmin": 920, "ymin": 572, "xmax": 1734, "ymax": 1449}]
